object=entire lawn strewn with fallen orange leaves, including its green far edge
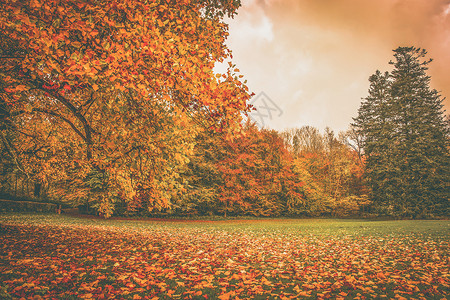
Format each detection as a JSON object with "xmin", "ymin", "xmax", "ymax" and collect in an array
[{"xmin": 0, "ymin": 214, "xmax": 450, "ymax": 299}]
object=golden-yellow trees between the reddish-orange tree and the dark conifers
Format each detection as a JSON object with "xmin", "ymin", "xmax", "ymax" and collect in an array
[{"xmin": 281, "ymin": 126, "xmax": 368, "ymax": 216}]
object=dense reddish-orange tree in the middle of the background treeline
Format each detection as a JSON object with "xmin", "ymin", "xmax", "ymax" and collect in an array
[{"xmin": 216, "ymin": 123, "xmax": 303, "ymax": 216}]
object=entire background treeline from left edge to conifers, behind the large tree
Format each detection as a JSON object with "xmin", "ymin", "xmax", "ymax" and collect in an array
[{"xmin": 1, "ymin": 122, "xmax": 370, "ymax": 217}]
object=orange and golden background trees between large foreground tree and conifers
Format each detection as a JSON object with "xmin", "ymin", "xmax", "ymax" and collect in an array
[{"xmin": 170, "ymin": 123, "xmax": 368, "ymax": 216}]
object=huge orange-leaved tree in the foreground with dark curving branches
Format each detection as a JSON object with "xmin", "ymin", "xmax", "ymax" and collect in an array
[{"xmin": 0, "ymin": 0, "xmax": 250, "ymax": 215}]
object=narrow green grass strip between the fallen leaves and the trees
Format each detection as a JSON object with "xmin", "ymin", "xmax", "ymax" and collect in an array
[{"xmin": 0, "ymin": 213, "xmax": 450, "ymax": 238}]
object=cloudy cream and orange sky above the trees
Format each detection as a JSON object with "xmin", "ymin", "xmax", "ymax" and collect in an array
[{"xmin": 219, "ymin": 0, "xmax": 450, "ymax": 131}]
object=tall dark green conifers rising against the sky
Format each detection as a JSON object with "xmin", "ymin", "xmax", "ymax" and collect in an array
[{"xmin": 354, "ymin": 47, "xmax": 450, "ymax": 217}]
